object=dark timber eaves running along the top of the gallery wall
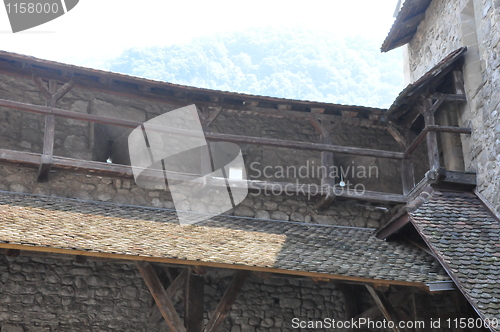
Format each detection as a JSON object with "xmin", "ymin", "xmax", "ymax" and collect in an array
[{"xmin": 0, "ymin": 51, "xmax": 386, "ymax": 128}]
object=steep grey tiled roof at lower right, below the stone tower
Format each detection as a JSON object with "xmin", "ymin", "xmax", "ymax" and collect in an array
[{"xmin": 410, "ymin": 191, "xmax": 500, "ymax": 331}]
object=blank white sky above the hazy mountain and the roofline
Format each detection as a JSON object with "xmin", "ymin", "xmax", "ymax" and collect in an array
[{"xmin": 0, "ymin": 0, "xmax": 397, "ymax": 67}]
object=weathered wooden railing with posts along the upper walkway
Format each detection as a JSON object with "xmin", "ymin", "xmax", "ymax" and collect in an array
[{"xmin": 0, "ymin": 99, "xmax": 471, "ymax": 203}]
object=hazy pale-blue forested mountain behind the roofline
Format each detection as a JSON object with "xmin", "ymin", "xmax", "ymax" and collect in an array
[{"xmin": 109, "ymin": 28, "xmax": 403, "ymax": 107}]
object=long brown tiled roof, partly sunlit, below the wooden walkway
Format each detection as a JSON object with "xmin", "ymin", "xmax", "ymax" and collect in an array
[{"xmin": 0, "ymin": 192, "xmax": 449, "ymax": 283}]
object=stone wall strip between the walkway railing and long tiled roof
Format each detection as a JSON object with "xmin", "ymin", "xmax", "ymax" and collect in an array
[{"xmin": 0, "ymin": 165, "xmax": 389, "ymax": 228}]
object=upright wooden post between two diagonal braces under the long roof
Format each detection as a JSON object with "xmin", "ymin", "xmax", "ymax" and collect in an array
[{"xmin": 184, "ymin": 269, "xmax": 205, "ymax": 332}]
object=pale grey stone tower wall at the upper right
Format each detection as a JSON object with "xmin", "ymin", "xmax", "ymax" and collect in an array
[{"xmin": 408, "ymin": 0, "xmax": 500, "ymax": 212}]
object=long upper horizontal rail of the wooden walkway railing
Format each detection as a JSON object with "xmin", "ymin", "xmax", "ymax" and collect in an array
[{"xmin": 0, "ymin": 99, "xmax": 403, "ymax": 159}]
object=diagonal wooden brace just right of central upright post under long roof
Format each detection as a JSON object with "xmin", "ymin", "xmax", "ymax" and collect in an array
[{"xmin": 203, "ymin": 271, "xmax": 249, "ymax": 332}]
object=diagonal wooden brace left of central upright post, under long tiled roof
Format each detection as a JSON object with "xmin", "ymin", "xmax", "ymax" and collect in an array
[{"xmin": 137, "ymin": 262, "xmax": 186, "ymax": 332}]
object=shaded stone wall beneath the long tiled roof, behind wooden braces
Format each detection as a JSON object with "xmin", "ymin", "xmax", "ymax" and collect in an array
[{"xmin": 0, "ymin": 255, "xmax": 344, "ymax": 332}]
